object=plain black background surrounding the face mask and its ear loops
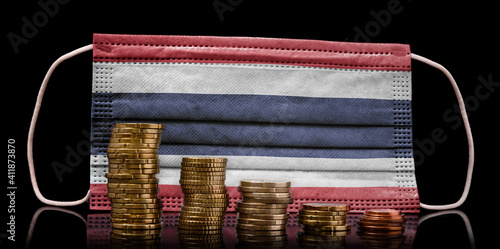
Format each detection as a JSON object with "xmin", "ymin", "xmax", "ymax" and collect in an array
[{"xmin": 0, "ymin": 0, "xmax": 500, "ymax": 248}]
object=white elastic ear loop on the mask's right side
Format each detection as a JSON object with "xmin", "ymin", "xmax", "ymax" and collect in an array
[{"xmin": 411, "ymin": 54, "xmax": 474, "ymax": 210}]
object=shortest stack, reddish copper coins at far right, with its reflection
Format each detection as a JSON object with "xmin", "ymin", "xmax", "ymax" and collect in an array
[{"xmin": 357, "ymin": 209, "xmax": 406, "ymax": 248}]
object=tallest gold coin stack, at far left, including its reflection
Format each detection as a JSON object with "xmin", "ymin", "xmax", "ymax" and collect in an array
[{"xmin": 106, "ymin": 123, "xmax": 165, "ymax": 248}]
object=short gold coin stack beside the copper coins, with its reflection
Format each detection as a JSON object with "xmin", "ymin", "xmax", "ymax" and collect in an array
[{"xmin": 297, "ymin": 203, "xmax": 351, "ymax": 248}]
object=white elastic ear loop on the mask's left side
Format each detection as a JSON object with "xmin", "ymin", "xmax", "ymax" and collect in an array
[{"xmin": 28, "ymin": 44, "xmax": 92, "ymax": 206}]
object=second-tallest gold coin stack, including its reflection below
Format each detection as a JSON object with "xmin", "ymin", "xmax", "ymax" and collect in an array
[{"xmin": 177, "ymin": 157, "xmax": 229, "ymax": 248}]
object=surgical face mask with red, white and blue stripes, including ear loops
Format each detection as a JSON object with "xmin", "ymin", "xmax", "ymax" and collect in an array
[{"xmin": 28, "ymin": 34, "xmax": 474, "ymax": 213}]
